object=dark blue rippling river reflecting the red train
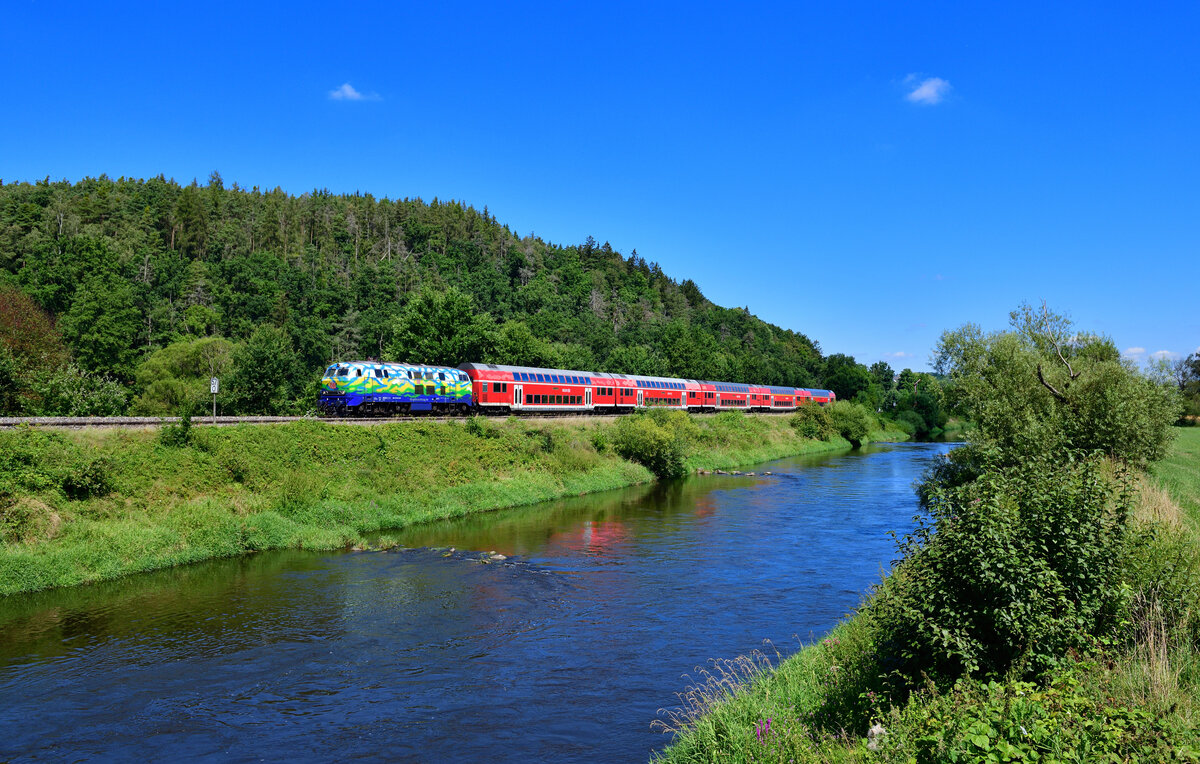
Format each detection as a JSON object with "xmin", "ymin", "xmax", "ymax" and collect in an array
[{"xmin": 0, "ymin": 444, "xmax": 949, "ymax": 762}]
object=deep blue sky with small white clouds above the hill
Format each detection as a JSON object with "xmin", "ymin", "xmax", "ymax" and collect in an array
[{"xmin": 0, "ymin": 1, "xmax": 1200, "ymax": 368}]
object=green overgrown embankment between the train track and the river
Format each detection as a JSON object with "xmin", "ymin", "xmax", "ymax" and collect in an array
[{"xmin": 0, "ymin": 411, "xmax": 905, "ymax": 595}]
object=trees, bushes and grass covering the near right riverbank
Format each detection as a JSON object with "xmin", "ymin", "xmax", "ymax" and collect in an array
[{"xmin": 661, "ymin": 306, "xmax": 1200, "ymax": 763}]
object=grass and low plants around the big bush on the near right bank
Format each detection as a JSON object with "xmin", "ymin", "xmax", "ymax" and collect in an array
[{"xmin": 658, "ymin": 428, "xmax": 1200, "ymax": 763}]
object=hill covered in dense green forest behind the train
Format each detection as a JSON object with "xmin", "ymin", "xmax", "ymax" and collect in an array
[{"xmin": 0, "ymin": 173, "xmax": 835, "ymax": 408}]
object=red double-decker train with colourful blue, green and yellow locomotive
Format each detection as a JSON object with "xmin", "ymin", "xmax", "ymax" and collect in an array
[{"xmin": 319, "ymin": 361, "xmax": 836, "ymax": 416}]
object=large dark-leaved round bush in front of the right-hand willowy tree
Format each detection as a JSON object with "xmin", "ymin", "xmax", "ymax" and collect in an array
[{"xmin": 870, "ymin": 455, "xmax": 1128, "ymax": 686}]
